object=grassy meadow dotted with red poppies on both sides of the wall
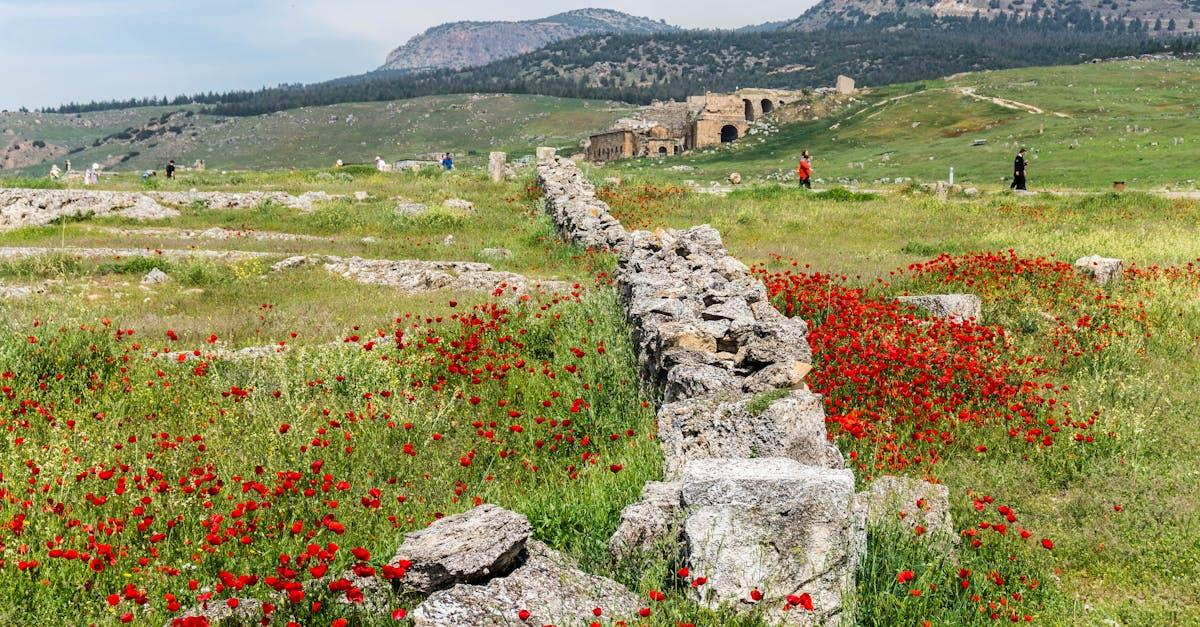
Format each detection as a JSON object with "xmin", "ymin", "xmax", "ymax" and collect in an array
[{"xmin": 0, "ymin": 166, "xmax": 1200, "ymax": 626}]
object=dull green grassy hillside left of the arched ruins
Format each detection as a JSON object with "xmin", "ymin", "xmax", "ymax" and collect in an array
[{"xmin": 0, "ymin": 95, "xmax": 629, "ymax": 175}]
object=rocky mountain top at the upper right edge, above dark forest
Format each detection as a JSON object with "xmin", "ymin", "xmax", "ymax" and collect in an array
[{"xmin": 785, "ymin": 0, "xmax": 1200, "ymax": 35}]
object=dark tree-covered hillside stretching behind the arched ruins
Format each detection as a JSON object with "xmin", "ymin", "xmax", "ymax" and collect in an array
[{"xmin": 177, "ymin": 20, "xmax": 1198, "ymax": 115}]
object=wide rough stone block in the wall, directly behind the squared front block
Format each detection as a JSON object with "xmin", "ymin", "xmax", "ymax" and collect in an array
[{"xmin": 659, "ymin": 389, "xmax": 845, "ymax": 477}]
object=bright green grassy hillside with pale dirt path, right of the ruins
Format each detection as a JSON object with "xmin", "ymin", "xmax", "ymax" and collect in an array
[{"xmin": 617, "ymin": 58, "xmax": 1200, "ymax": 190}]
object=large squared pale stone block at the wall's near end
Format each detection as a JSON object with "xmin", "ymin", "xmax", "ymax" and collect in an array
[{"xmin": 683, "ymin": 458, "xmax": 857, "ymax": 626}]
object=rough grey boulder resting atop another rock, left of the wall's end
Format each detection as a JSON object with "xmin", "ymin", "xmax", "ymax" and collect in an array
[{"xmin": 391, "ymin": 504, "xmax": 532, "ymax": 593}]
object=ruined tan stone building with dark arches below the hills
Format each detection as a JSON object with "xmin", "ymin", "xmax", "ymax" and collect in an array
[{"xmin": 587, "ymin": 89, "xmax": 808, "ymax": 162}]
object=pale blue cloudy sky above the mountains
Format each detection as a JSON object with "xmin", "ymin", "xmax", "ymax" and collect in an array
[{"xmin": 0, "ymin": 0, "xmax": 815, "ymax": 109}]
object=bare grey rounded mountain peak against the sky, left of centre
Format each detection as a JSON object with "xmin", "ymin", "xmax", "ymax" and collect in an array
[{"xmin": 379, "ymin": 8, "xmax": 679, "ymax": 72}]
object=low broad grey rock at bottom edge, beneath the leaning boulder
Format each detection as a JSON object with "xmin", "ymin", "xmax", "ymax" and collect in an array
[{"xmin": 412, "ymin": 541, "xmax": 638, "ymax": 627}]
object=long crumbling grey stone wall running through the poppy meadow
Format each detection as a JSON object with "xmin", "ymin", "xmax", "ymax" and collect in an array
[{"xmin": 538, "ymin": 152, "xmax": 865, "ymax": 626}]
